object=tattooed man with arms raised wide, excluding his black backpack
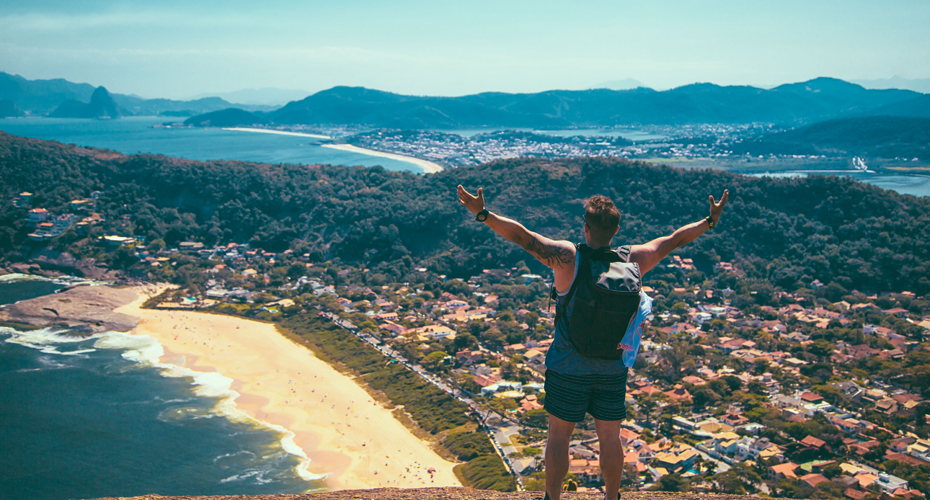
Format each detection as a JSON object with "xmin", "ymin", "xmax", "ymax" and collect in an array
[{"xmin": 458, "ymin": 186, "xmax": 729, "ymax": 500}]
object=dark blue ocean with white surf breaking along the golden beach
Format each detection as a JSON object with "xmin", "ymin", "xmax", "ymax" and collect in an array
[{"xmin": 0, "ymin": 281, "xmax": 322, "ymax": 500}]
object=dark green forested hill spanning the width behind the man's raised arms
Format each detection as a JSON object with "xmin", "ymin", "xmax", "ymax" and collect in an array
[{"xmin": 0, "ymin": 134, "xmax": 930, "ymax": 293}]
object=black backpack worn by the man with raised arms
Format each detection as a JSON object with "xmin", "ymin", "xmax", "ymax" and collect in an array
[{"xmin": 556, "ymin": 244, "xmax": 642, "ymax": 360}]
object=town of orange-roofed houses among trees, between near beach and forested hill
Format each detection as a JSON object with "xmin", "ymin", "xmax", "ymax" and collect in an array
[{"xmin": 16, "ymin": 193, "xmax": 930, "ymax": 500}]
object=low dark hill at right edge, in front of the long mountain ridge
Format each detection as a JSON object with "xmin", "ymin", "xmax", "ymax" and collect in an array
[{"xmin": 732, "ymin": 116, "xmax": 930, "ymax": 159}]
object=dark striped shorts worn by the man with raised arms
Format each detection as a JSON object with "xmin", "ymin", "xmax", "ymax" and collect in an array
[{"xmin": 545, "ymin": 370, "xmax": 627, "ymax": 422}]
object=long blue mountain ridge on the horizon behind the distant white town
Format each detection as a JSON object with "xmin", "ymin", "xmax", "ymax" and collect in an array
[{"xmin": 258, "ymin": 78, "xmax": 920, "ymax": 128}]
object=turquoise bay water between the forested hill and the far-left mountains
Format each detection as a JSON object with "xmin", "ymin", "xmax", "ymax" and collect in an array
[{"xmin": 0, "ymin": 116, "xmax": 422, "ymax": 173}]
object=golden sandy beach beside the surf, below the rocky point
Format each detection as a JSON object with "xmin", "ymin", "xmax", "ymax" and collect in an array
[{"xmin": 99, "ymin": 287, "xmax": 461, "ymax": 489}]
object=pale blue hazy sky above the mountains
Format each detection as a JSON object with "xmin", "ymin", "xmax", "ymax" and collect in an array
[{"xmin": 0, "ymin": 0, "xmax": 930, "ymax": 98}]
